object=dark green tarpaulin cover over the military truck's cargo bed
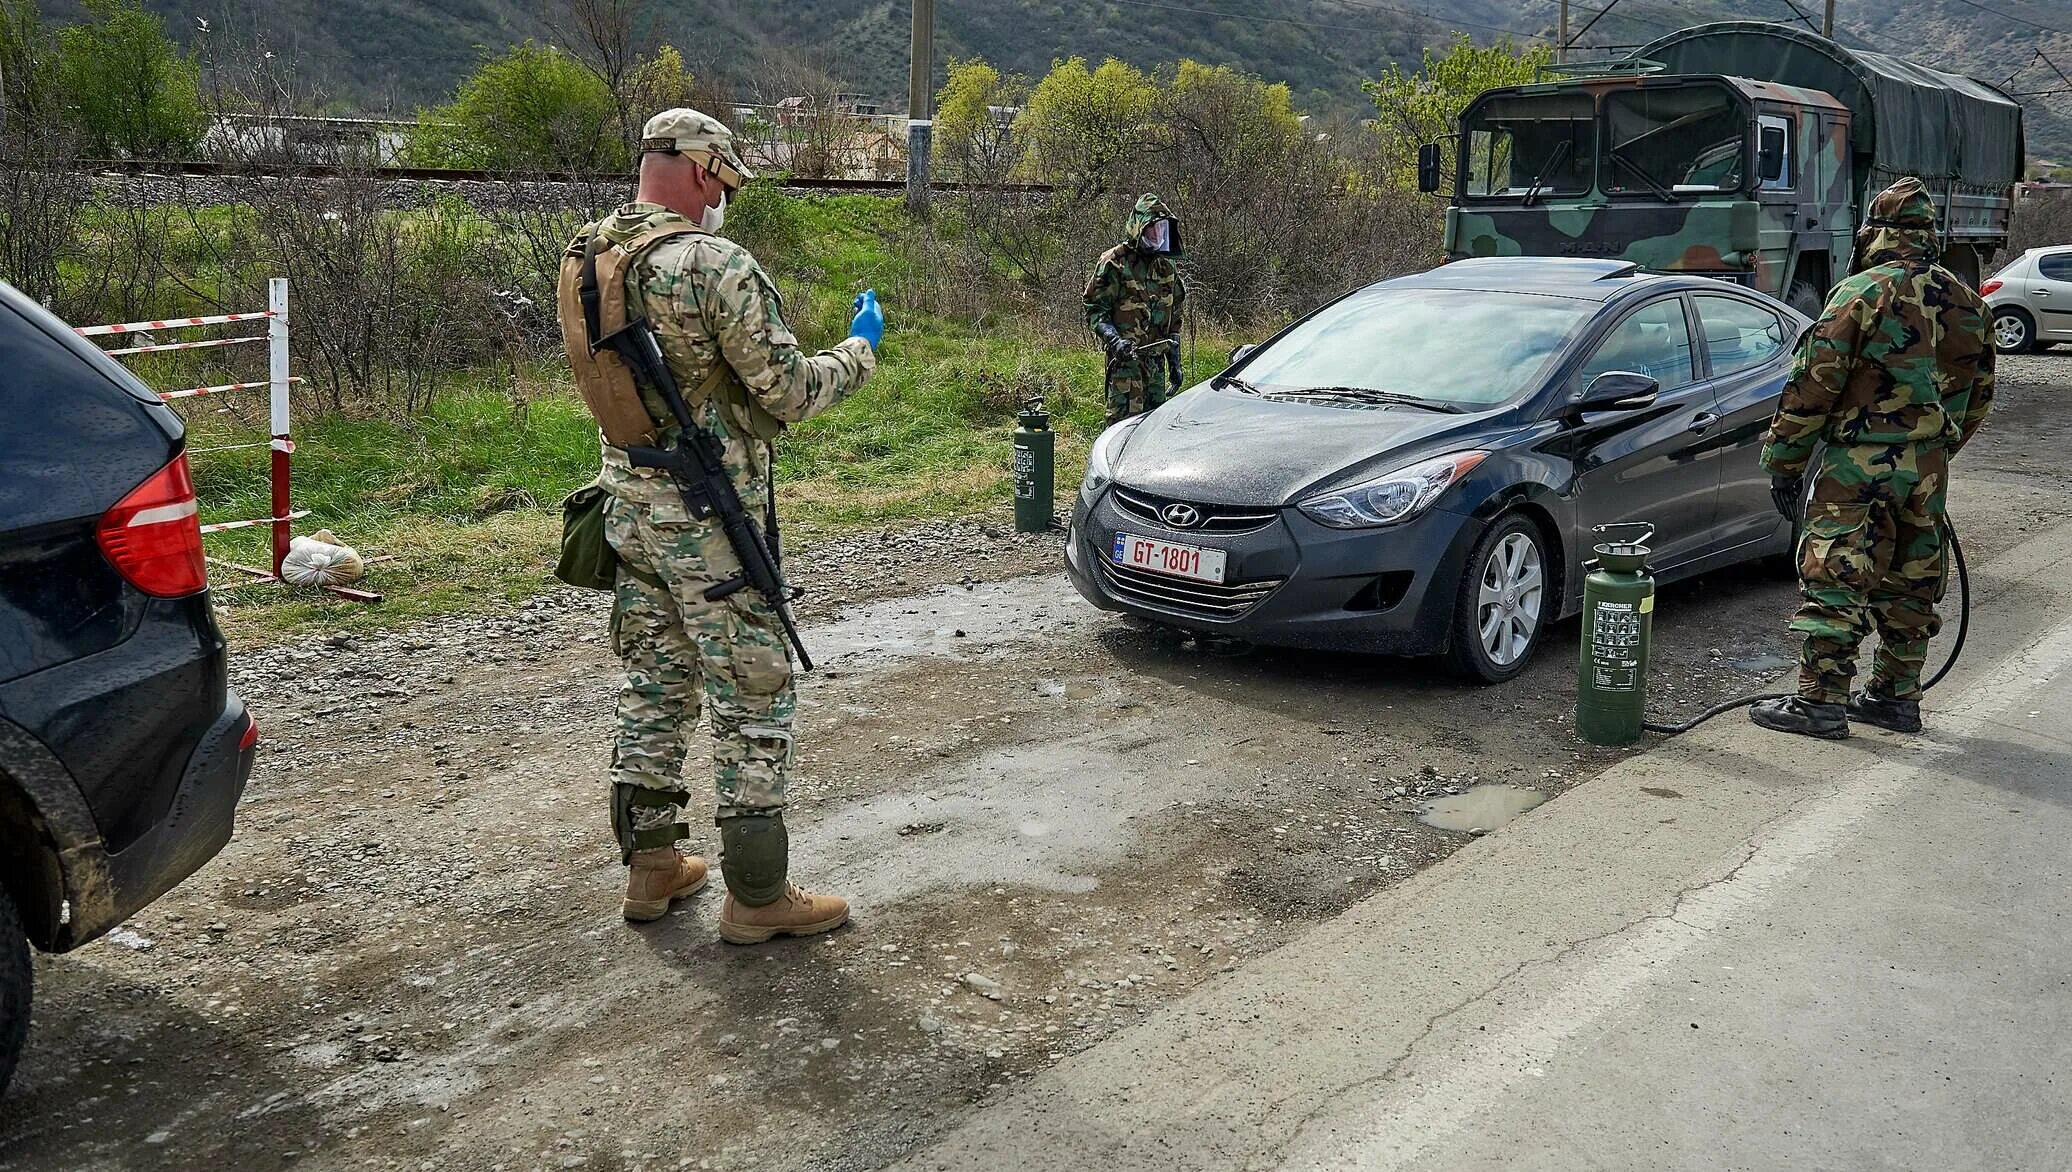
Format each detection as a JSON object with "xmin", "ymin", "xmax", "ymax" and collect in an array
[{"xmin": 1633, "ymin": 21, "xmax": 2022, "ymax": 191}]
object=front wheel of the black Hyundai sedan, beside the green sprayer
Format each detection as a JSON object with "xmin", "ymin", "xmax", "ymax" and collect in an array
[{"xmin": 1446, "ymin": 514, "xmax": 1558, "ymax": 683}]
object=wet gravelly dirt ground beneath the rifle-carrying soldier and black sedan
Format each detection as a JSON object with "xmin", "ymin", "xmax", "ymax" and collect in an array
[{"xmin": 0, "ymin": 356, "xmax": 2072, "ymax": 1172}]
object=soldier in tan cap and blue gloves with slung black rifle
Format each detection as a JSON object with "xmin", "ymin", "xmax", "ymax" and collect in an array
[{"xmin": 580, "ymin": 110, "xmax": 885, "ymax": 944}]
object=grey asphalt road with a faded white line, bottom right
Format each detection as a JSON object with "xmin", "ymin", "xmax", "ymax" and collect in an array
[{"xmin": 901, "ymin": 513, "xmax": 2072, "ymax": 1172}]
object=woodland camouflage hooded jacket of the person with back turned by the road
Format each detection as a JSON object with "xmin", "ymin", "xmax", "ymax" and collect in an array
[{"xmin": 1763, "ymin": 193, "xmax": 1993, "ymax": 476}]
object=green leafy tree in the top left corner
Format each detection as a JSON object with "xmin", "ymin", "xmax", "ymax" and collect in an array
[{"xmin": 58, "ymin": 0, "xmax": 203, "ymax": 157}]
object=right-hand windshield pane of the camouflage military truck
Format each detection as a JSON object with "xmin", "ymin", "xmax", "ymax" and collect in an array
[{"xmin": 1604, "ymin": 85, "xmax": 1749, "ymax": 199}]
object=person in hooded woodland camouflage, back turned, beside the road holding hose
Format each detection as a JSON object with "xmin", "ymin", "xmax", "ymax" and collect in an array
[{"xmin": 1753, "ymin": 178, "xmax": 1993, "ymax": 739}]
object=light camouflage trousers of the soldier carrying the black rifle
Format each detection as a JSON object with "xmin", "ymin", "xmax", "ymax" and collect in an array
[{"xmin": 605, "ymin": 490, "xmax": 796, "ymax": 830}]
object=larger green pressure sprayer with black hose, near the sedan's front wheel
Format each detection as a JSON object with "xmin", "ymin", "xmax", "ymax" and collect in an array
[{"xmin": 1575, "ymin": 516, "xmax": 1970, "ymax": 745}]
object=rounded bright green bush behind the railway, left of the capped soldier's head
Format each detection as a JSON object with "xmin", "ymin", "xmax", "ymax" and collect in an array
[{"xmin": 404, "ymin": 41, "xmax": 632, "ymax": 172}]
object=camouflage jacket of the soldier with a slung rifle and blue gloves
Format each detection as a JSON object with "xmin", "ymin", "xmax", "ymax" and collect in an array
[{"xmin": 597, "ymin": 203, "xmax": 876, "ymax": 520}]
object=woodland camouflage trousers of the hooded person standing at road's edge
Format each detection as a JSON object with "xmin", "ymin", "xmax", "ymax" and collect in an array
[{"xmin": 1792, "ymin": 443, "xmax": 1950, "ymax": 704}]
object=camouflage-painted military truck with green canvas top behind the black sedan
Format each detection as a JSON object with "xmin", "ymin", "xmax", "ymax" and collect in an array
[{"xmin": 1419, "ymin": 21, "xmax": 2022, "ymax": 317}]
